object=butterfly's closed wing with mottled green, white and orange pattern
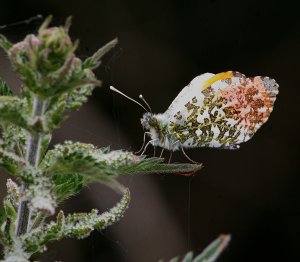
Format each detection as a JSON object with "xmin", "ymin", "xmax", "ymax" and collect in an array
[{"xmin": 165, "ymin": 71, "xmax": 278, "ymax": 148}]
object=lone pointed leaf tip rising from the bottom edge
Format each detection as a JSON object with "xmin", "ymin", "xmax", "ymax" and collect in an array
[{"xmin": 193, "ymin": 235, "xmax": 230, "ymax": 262}]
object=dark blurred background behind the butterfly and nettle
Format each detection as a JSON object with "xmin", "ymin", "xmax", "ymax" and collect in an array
[{"xmin": 0, "ymin": 0, "xmax": 300, "ymax": 262}]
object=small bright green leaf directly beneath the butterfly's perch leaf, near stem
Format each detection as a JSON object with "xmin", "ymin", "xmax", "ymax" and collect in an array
[{"xmin": 52, "ymin": 174, "xmax": 85, "ymax": 202}]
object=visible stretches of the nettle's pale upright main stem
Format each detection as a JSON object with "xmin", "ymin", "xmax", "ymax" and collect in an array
[{"xmin": 16, "ymin": 96, "xmax": 47, "ymax": 236}]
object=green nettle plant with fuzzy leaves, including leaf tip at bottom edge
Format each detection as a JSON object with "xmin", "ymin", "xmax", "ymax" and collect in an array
[{"xmin": 0, "ymin": 17, "xmax": 229, "ymax": 262}]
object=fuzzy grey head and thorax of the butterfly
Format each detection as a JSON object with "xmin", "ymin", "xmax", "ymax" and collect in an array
[{"xmin": 141, "ymin": 112, "xmax": 178, "ymax": 151}]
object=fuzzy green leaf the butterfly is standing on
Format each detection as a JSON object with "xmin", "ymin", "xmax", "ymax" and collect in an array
[{"xmin": 41, "ymin": 141, "xmax": 201, "ymax": 194}]
